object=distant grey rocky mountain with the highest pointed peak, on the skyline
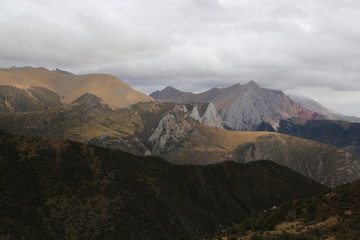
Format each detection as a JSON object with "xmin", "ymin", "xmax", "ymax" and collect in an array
[{"xmin": 150, "ymin": 81, "xmax": 323, "ymax": 131}]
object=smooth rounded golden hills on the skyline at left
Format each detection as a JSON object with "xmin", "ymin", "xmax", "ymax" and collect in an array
[{"xmin": 0, "ymin": 67, "xmax": 154, "ymax": 109}]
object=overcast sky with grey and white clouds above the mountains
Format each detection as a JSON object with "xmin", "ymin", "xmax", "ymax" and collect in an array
[{"xmin": 0, "ymin": 0, "xmax": 360, "ymax": 116}]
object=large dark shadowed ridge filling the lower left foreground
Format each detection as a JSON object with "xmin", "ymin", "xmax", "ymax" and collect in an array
[{"xmin": 0, "ymin": 132, "xmax": 326, "ymax": 240}]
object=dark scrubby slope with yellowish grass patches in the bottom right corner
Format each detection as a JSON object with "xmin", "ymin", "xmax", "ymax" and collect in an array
[{"xmin": 217, "ymin": 181, "xmax": 360, "ymax": 240}]
